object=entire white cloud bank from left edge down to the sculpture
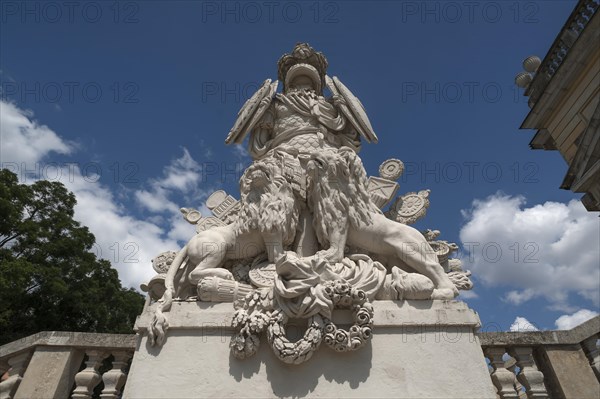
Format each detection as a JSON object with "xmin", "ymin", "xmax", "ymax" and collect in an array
[{"xmin": 0, "ymin": 102, "xmax": 199, "ymax": 288}]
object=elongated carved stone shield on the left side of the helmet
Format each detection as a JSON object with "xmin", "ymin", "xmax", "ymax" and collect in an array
[{"xmin": 225, "ymin": 79, "xmax": 279, "ymax": 144}]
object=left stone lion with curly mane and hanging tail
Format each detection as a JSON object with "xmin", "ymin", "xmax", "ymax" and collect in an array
[{"xmin": 149, "ymin": 160, "xmax": 299, "ymax": 346}]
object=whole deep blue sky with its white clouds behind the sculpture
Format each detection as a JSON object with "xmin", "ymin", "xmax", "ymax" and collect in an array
[{"xmin": 0, "ymin": 1, "xmax": 600, "ymax": 330}]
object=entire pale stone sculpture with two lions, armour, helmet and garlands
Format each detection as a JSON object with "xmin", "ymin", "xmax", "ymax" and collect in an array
[{"xmin": 146, "ymin": 44, "xmax": 472, "ymax": 364}]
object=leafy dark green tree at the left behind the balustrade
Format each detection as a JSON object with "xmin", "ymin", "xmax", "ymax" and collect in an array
[{"xmin": 0, "ymin": 169, "xmax": 144, "ymax": 344}]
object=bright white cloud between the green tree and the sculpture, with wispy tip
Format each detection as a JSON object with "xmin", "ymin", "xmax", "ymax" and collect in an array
[{"xmin": 64, "ymin": 149, "xmax": 200, "ymax": 288}]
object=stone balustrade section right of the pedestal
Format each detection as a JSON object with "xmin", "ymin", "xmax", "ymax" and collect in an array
[{"xmin": 478, "ymin": 316, "xmax": 600, "ymax": 399}]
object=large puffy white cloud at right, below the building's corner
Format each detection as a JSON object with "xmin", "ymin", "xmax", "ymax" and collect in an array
[{"xmin": 460, "ymin": 194, "xmax": 600, "ymax": 311}]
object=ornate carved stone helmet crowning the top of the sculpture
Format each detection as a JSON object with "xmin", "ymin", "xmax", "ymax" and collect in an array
[{"xmin": 277, "ymin": 43, "xmax": 328, "ymax": 95}]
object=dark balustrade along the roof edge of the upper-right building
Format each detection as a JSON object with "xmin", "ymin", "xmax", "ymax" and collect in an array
[{"xmin": 525, "ymin": 0, "xmax": 600, "ymax": 107}]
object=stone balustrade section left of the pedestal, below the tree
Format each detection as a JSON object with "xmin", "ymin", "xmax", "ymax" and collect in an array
[{"xmin": 0, "ymin": 331, "xmax": 136, "ymax": 399}]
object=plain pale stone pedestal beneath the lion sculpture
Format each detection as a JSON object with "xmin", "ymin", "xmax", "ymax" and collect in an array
[{"xmin": 123, "ymin": 301, "xmax": 496, "ymax": 399}]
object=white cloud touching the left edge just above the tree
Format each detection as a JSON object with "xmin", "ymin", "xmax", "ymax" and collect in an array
[{"xmin": 0, "ymin": 100, "xmax": 74, "ymax": 170}]
